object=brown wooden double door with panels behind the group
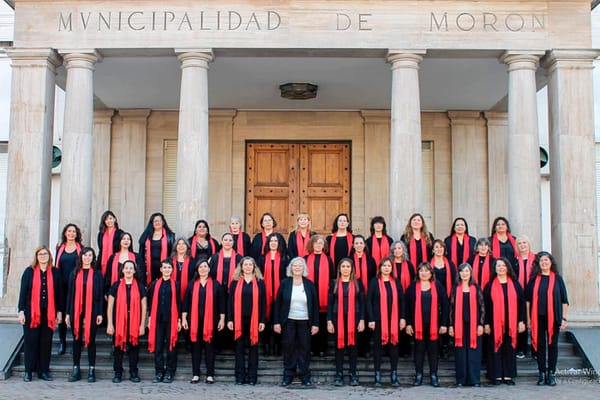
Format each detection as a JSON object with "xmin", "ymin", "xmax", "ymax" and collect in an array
[{"xmin": 246, "ymin": 142, "xmax": 351, "ymax": 239}]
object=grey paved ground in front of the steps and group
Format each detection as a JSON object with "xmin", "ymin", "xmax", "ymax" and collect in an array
[{"xmin": 0, "ymin": 376, "xmax": 600, "ymax": 400}]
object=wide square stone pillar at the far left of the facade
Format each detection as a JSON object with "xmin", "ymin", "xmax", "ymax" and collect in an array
[{"xmin": 0, "ymin": 49, "xmax": 61, "ymax": 310}]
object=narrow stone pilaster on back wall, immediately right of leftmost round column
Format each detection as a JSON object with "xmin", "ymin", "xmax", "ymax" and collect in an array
[{"xmin": 90, "ymin": 110, "xmax": 114, "ymax": 248}]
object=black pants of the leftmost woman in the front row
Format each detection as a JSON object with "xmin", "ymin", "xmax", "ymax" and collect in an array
[{"xmin": 23, "ymin": 308, "xmax": 54, "ymax": 374}]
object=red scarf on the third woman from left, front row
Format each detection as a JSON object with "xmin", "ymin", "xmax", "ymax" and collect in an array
[{"xmin": 115, "ymin": 278, "xmax": 142, "ymax": 351}]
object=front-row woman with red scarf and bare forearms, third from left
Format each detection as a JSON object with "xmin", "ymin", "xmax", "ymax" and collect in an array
[{"xmin": 106, "ymin": 260, "xmax": 148, "ymax": 383}]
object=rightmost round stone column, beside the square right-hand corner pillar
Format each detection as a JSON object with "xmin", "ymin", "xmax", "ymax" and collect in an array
[{"xmin": 501, "ymin": 51, "xmax": 544, "ymax": 249}]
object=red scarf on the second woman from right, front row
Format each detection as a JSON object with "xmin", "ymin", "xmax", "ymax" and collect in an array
[{"xmin": 491, "ymin": 278, "xmax": 518, "ymax": 352}]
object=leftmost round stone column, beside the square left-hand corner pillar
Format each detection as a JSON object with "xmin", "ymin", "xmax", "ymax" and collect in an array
[{"xmin": 59, "ymin": 51, "xmax": 99, "ymax": 245}]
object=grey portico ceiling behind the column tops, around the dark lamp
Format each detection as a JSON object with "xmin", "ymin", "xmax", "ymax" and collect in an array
[{"xmin": 83, "ymin": 50, "xmax": 520, "ymax": 111}]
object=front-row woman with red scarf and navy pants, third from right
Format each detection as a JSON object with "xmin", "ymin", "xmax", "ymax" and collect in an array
[{"xmin": 448, "ymin": 263, "xmax": 485, "ymax": 387}]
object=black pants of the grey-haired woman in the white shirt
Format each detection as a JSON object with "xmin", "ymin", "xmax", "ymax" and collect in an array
[{"xmin": 281, "ymin": 319, "xmax": 311, "ymax": 382}]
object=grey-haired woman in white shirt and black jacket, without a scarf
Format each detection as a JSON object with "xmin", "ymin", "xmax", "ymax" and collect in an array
[{"xmin": 273, "ymin": 257, "xmax": 319, "ymax": 386}]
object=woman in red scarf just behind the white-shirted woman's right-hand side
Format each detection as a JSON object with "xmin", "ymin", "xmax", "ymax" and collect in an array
[{"xmin": 304, "ymin": 235, "xmax": 334, "ymax": 357}]
